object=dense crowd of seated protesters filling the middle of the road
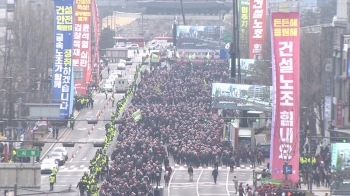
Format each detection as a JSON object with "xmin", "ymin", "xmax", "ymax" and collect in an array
[{"xmin": 101, "ymin": 62, "xmax": 232, "ymax": 196}]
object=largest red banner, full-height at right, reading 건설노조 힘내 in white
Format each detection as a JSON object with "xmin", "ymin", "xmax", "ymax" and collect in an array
[{"xmin": 271, "ymin": 12, "xmax": 300, "ymax": 182}]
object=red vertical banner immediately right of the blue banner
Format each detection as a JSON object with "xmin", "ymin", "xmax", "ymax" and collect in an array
[{"xmin": 73, "ymin": 0, "xmax": 91, "ymax": 95}]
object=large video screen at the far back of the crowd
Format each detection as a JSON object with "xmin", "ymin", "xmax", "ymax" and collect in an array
[{"xmin": 176, "ymin": 25, "xmax": 227, "ymax": 49}]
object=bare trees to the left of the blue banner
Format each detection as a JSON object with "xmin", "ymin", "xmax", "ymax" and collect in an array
[{"xmin": 4, "ymin": 1, "xmax": 54, "ymax": 101}]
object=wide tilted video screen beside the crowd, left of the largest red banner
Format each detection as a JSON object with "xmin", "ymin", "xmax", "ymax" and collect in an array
[{"xmin": 211, "ymin": 83, "xmax": 272, "ymax": 109}]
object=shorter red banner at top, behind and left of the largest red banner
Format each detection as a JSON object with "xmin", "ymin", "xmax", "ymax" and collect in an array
[{"xmin": 249, "ymin": 0, "xmax": 266, "ymax": 59}]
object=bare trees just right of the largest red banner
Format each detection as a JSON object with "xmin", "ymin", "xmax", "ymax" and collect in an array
[{"xmin": 300, "ymin": 28, "xmax": 333, "ymax": 135}]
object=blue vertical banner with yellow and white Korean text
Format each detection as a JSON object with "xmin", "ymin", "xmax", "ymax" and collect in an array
[{"xmin": 52, "ymin": 0, "xmax": 74, "ymax": 118}]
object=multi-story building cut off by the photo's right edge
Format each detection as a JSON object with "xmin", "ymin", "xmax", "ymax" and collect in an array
[{"xmin": 332, "ymin": 0, "xmax": 350, "ymax": 129}]
